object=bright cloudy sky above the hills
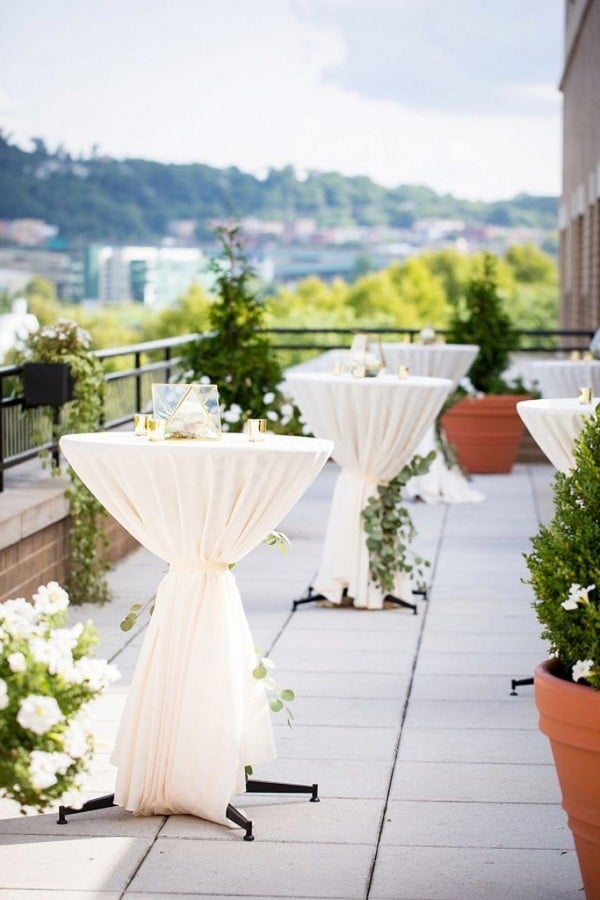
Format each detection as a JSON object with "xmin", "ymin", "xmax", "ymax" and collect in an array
[{"xmin": 0, "ymin": 0, "xmax": 564, "ymax": 201}]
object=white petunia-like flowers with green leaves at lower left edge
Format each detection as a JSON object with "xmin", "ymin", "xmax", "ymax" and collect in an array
[{"xmin": 0, "ymin": 581, "xmax": 120, "ymax": 812}]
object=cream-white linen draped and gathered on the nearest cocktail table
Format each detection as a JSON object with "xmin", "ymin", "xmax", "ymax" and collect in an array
[{"xmin": 60, "ymin": 433, "xmax": 332, "ymax": 825}]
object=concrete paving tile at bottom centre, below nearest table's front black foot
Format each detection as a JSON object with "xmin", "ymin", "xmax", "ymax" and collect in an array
[{"xmin": 131, "ymin": 838, "xmax": 373, "ymax": 900}]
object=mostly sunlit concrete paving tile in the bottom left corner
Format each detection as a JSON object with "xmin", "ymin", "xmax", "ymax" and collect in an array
[{"xmin": 0, "ymin": 835, "xmax": 152, "ymax": 891}]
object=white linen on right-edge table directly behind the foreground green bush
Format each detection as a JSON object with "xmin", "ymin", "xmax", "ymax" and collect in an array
[{"xmin": 517, "ymin": 397, "xmax": 600, "ymax": 472}]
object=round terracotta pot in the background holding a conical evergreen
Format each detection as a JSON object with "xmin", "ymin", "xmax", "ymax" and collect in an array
[{"xmin": 442, "ymin": 394, "xmax": 528, "ymax": 474}]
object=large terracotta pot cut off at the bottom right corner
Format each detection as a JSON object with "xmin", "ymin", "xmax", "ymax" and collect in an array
[{"xmin": 534, "ymin": 660, "xmax": 600, "ymax": 900}]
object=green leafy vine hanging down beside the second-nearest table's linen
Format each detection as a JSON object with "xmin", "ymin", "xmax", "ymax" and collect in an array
[{"xmin": 362, "ymin": 450, "xmax": 435, "ymax": 594}]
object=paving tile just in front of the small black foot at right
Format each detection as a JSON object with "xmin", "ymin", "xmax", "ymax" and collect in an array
[{"xmin": 405, "ymin": 696, "xmax": 538, "ymax": 730}]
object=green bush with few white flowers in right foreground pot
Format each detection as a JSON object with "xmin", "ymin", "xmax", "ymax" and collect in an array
[{"xmin": 525, "ymin": 412, "xmax": 600, "ymax": 690}]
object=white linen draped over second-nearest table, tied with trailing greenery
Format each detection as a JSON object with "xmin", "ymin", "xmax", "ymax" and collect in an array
[{"xmin": 286, "ymin": 372, "xmax": 452, "ymax": 609}]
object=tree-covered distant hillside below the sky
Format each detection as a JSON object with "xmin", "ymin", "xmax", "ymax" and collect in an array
[{"xmin": 0, "ymin": 134, "xmax": 558, "ymax": 243}]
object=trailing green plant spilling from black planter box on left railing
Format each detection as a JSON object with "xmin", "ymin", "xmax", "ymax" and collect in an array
[{"xmin": 23, "ymin": 319, "xmax": 110, "ymax": 604}]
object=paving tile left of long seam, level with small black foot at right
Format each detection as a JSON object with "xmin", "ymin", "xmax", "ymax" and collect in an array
[{"xmin": 275, "ymin": 666, "xmax": 408, "ymax": 700}]
